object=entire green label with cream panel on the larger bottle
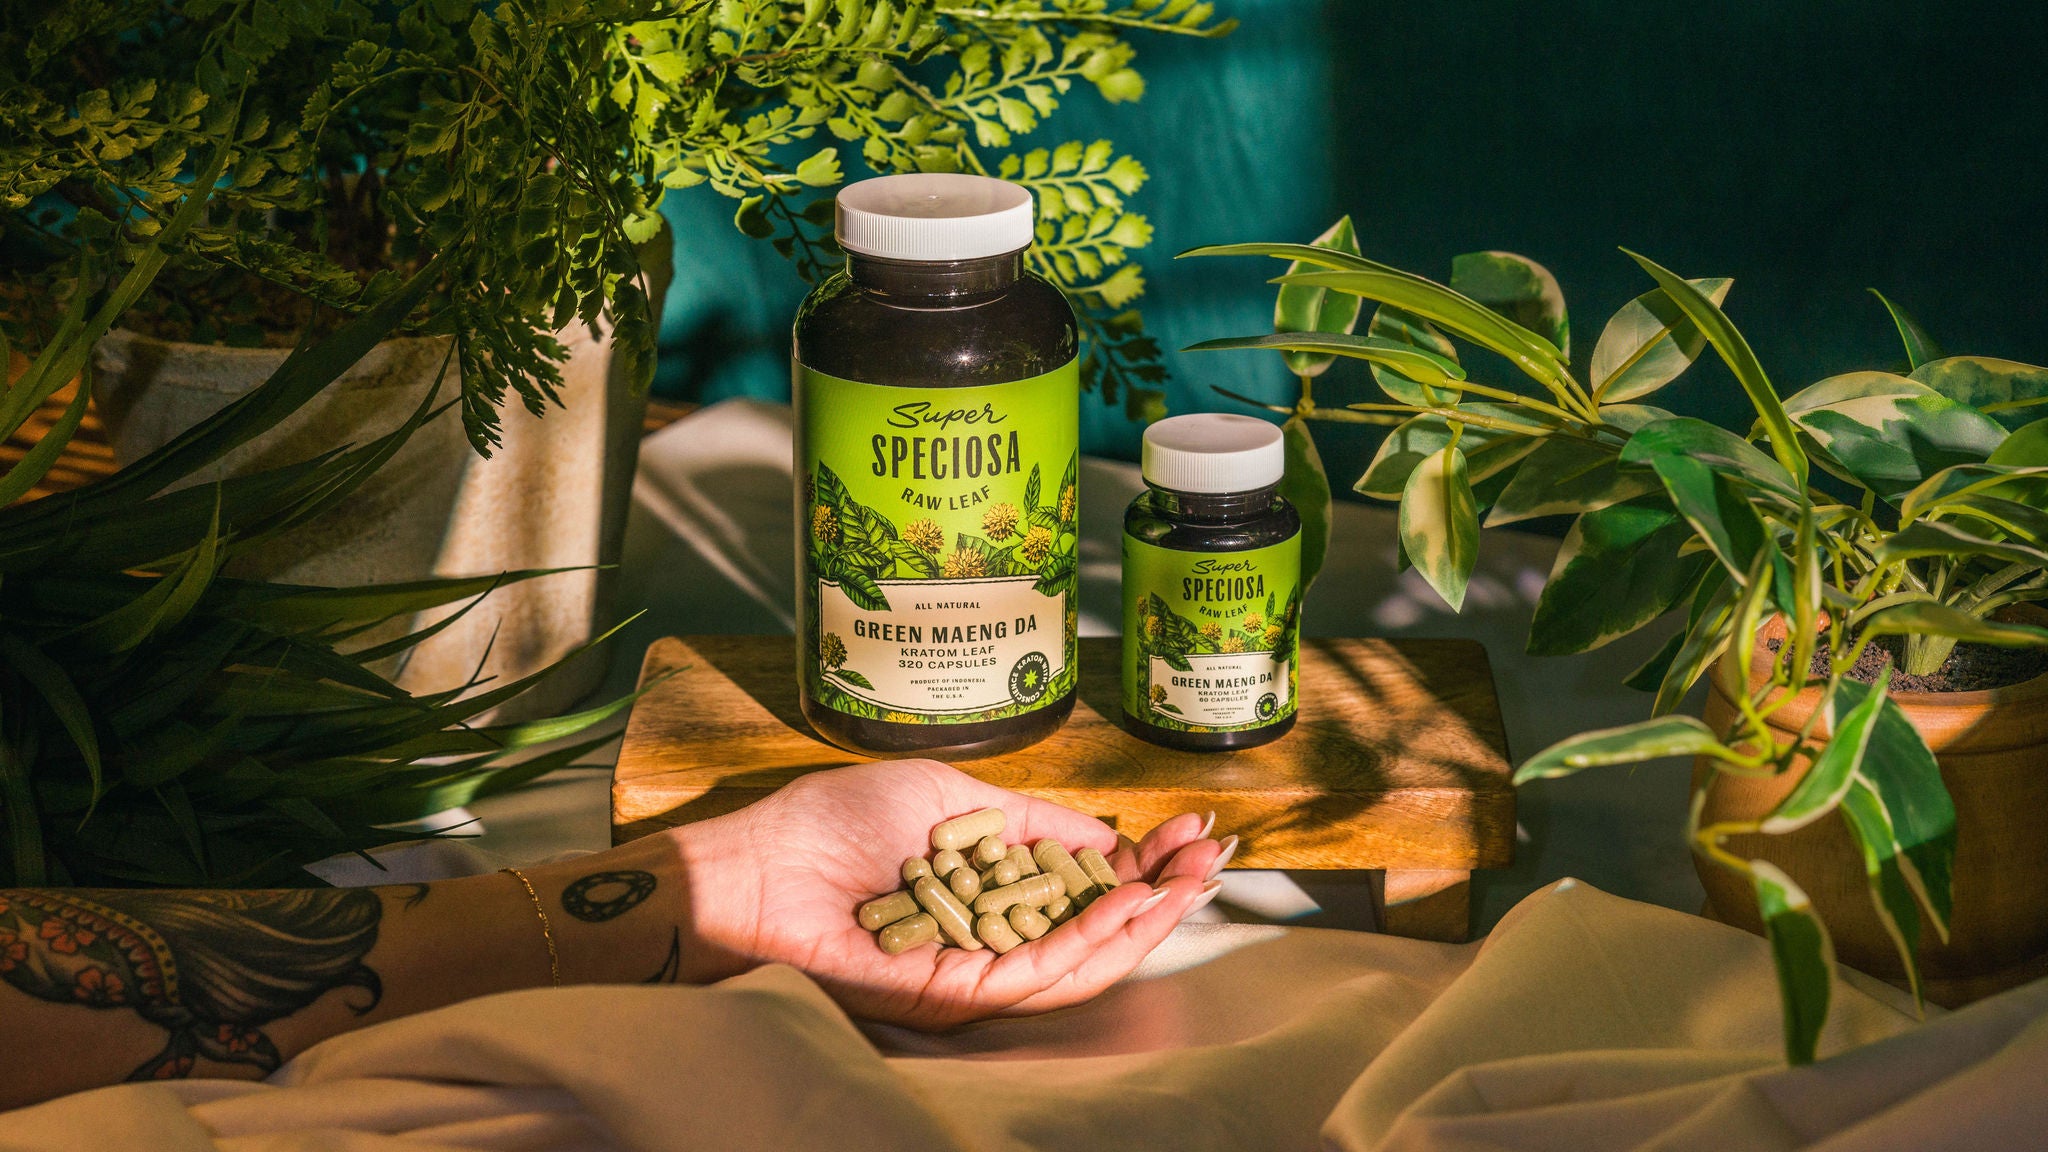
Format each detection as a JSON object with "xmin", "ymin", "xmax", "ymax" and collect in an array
[{"xmin": 795, "ymin": 361, "xmax": 1081, "ymax": 724}]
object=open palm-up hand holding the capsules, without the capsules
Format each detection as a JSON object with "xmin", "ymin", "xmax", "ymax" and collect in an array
[{"xmin": 674, "ymin": 760, "xmax": 1223, "ymax": 1029}]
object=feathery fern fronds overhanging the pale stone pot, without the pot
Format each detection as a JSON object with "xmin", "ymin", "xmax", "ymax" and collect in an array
[{"xmin": 0, "ymin": 0, "xmax": 1231, "ymax": 451}]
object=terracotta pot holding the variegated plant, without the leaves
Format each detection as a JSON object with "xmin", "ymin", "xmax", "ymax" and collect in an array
[{"xmin": 1694, "ymin": 609, "xmax": 2048, "ymax": 1006}]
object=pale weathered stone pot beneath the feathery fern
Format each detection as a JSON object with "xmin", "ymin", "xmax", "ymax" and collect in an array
[{"xmin": 94, "ymin": 240, "xmax": 668, "ymax": 722}]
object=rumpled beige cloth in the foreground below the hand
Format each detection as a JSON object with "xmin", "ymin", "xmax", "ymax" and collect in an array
[{"xmin": 0, "ymin": 881, "xmax": 2048, "ymax": 1152}]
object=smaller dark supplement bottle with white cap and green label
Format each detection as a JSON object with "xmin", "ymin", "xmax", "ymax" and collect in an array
[{"xmin": 1122, "ymin": 414, "xmax": 1300, "ymax": 752}]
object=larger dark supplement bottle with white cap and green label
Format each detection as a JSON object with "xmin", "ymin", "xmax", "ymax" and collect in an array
[{"xmin": 793, "ymin": 174, "xmax": 1079, "ymax": 758}]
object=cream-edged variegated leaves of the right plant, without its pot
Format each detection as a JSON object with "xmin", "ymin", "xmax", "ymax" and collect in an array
[{"xmin": 1186, "ymin": 228, "xmax": 2048, "ymax": 1062}]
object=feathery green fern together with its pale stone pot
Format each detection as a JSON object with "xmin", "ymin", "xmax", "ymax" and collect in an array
[{"xmin": 0, "ymin": 0, "xmax": 1231, "ymax": 711}]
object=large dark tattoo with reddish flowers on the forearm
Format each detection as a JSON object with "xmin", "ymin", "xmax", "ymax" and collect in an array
[{"xmin": 0, "ymin": 886, "xmax": 382, "ymax": 1080}]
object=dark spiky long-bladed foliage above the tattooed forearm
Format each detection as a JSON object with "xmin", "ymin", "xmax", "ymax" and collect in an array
[{"xmin": 0, "ymin": 132, "xmax": 625, "ymax": 886}]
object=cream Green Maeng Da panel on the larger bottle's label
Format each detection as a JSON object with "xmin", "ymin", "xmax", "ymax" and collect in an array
[{"xmin": 817, "ymin": 576, "xmax": 1067, "ymax": 715}]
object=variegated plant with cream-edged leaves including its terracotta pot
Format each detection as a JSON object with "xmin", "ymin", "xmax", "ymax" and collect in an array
[{"xmin": 1190, "ymin": 238, "xmax": 2048, "ymax": 1062}]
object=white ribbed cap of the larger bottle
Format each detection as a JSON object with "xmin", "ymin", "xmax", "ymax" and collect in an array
[{"xmin": 838, "ymin": 172, "xmax": 1032, "ymax": 260}]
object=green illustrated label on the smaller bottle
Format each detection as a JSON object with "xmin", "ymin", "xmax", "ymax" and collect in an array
[{"xmin": 1124, "ymin": 535, "xmax": 1300, "ymax": 732}]
